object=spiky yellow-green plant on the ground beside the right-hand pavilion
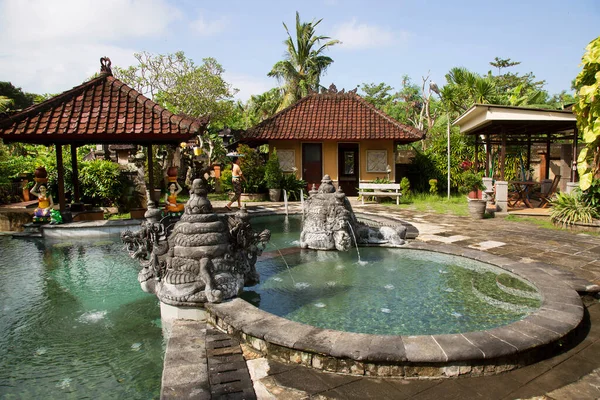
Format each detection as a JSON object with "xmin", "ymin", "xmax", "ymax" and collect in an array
[{"xmin": 550, "ymin": 190, "xmax": 598, "ymax": 226}]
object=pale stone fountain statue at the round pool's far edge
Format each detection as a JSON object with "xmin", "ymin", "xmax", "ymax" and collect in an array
[{"xmin": 300, "ymin": 175, "xmax": 406, "ymax": 251}]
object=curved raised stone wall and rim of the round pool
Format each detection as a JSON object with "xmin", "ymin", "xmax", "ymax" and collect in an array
[{"xmin": 206, "ymin": 214, "xmax": 583, "ymax": 378}]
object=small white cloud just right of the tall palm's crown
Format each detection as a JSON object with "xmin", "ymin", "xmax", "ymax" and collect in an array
[{"xmin": 332, "ymin": 18, "xmax": 410, "ymax": 50}]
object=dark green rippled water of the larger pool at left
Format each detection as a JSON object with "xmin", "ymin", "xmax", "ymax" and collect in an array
[{"xmin": 0, "ymin": 237, "xmax": 163, "ymax": 399}]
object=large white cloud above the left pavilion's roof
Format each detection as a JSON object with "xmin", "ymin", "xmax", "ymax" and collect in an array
[{"xmin": 0, "ymin": 0, "xmax": 181, "ymax": 93}]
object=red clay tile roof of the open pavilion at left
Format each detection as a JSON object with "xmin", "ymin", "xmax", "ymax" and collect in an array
[{"xmin": 0, "ymin": 70, "xmax": 208, "ymax": 144}]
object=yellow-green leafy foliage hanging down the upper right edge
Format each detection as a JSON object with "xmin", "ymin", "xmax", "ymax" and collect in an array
[{"xmin": 573, "ymin": 36, "xmax": 600, "ymax": 191}]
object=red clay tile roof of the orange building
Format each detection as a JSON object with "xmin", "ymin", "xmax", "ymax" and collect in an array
[{"xmin": 240, "ymin": 92, "xmax": 425, "ymax": 143}]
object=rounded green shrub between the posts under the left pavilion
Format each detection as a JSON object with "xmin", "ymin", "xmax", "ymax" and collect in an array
[{"xmin": 79, "ymin": 160, "xmax": 124, "ymax": 206}]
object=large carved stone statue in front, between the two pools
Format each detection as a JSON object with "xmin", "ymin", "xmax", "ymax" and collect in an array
[{"xmin": 121, "ymin": 179, "xmax": 271, "ymax": 306}]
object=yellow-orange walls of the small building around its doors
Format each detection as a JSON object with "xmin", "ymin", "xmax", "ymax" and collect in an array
[{"xmin": 269, "ymin": 140, "xmax": 395, "ymax": 182}]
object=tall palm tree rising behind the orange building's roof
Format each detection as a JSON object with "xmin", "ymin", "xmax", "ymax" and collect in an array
[{"xmin": 267, "ymin": 11, "xmax": 340, "ymax": 110}]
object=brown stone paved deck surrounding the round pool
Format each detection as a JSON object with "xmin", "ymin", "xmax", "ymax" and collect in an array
[{"xmin": 206, "ymin": 199, "xmax": 600, "ymax": 400}]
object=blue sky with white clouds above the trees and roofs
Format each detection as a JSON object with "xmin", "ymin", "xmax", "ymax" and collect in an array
[{"xmin": 0, "ymin": 0, "xmax": 600, "ymax": 100}]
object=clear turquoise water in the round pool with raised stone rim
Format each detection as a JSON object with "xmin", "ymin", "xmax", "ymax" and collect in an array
[{"xmin": 243, "ymin": 217, "xmax": 540, "ymax": 335}]
